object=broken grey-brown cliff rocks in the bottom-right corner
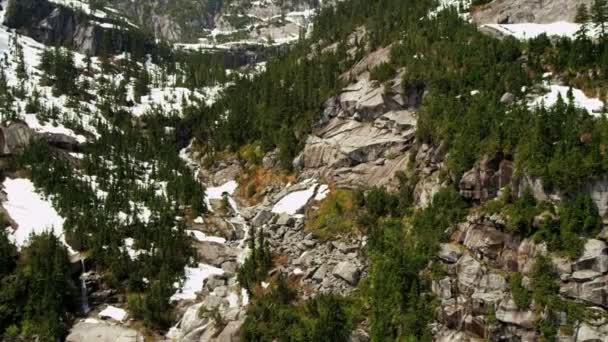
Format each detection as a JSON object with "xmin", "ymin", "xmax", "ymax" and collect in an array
[{"xmin": 431, "ymin": 214, "xmax": 608, "ymax": 341}]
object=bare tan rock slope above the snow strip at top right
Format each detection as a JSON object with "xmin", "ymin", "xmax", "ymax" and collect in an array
[{"xmin": 472, "ymin": 0, "xmax": 593, "ymax": 24}]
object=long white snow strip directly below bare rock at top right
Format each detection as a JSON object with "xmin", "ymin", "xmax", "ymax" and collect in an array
[{"xmin": 482, "ymin": 21, "xmax": 594, "ymax": 40}]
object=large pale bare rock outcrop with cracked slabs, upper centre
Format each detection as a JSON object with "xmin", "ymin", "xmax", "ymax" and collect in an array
[{"xmin": 297, "ymin": 73, "xmax": 417, "ymax": 187}]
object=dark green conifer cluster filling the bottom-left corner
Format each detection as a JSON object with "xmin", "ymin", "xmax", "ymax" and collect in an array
[{"xmin": 0, "ymin": 231, "xmax": 76, "ymax": 341}]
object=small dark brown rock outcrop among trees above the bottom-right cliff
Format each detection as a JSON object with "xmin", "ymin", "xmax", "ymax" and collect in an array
[{"xmin": 459, "ymin": 158, "xmax": 513, "ymax": 202}]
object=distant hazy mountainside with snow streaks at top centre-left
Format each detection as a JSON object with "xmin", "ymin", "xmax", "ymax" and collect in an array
[{"xmin": 97, "ymin": 0, "xmax": 320, "ymax": 44}]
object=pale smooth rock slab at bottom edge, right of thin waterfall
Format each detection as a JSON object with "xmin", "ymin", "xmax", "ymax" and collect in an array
[{"xmin": 66, "ymin": 321, "xmax": 146, "ymax": 342}]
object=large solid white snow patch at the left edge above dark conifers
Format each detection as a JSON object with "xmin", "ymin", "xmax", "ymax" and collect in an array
[{"xmin": 3, "ymin": 178, "xmax": 74, "ymax": 253}]
